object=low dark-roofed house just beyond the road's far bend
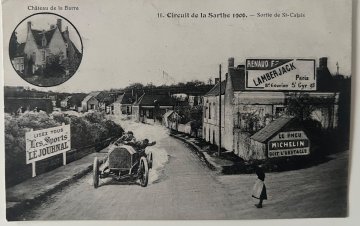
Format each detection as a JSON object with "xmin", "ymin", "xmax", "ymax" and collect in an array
[{"xmin": 133, "ymin": 93, "xmax": 175, "ymax": 123}]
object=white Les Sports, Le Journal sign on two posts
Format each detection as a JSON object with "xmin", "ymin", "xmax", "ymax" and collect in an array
[{"xmin": 25, "ymin": 124, "xmax": 71, "ymax": 177}]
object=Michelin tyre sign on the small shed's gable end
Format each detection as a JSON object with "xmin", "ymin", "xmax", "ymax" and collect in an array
[{"xmin": 268, "ymin": 131, "xmax": 310, "ymax": 158}]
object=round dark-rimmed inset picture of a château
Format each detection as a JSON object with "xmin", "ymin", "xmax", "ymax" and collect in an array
[{"xmin": 9, "ymin": 13, "xmax": 83, "ymax": 87}]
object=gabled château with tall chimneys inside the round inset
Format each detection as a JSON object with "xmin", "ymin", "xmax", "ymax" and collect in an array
[{"xmin": 10, "ymin": 19, "xmax": 82, "ymax": 75}]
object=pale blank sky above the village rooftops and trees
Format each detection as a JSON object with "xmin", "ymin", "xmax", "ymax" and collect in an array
[{"xmin": 3, "ymin": 0, "xmax": 352, "ymax": 92}]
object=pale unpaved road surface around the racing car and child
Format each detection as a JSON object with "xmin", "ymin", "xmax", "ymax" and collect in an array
[{"xmin": 17, "ymin": 122, "xmax": 348, "ymax": 220}]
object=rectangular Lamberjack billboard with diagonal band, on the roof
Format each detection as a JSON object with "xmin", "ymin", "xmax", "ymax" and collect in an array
[{"xmin": 246, "ymin": 59, "xmax": 316, "ymax": 91}]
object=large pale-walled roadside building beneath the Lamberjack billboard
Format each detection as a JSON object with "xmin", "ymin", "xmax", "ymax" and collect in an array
[{"xmin": 202, "ymin": 58, "xmax": 339, "ymax": 159}]
